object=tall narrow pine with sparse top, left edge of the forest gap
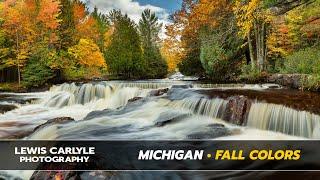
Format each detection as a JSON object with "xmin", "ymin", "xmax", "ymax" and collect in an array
[{"xmin": 139, "ymin": 9, "xmax": 168, "ymax": 78}]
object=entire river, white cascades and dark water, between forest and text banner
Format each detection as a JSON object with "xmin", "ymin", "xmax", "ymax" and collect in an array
[{"xmin": 0, "ymin": 80, "xmax": 320, "ymax": 178}]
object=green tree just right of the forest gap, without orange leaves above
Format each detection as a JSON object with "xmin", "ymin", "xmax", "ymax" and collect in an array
[{"xmin": 200, "ymin": 11, "xmax": 243, "ymax": 80}]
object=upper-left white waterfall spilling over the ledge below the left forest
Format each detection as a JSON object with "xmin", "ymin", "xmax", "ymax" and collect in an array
[{"xmin": 42, "ymin": 82, "xmax": 149, "ymax": 108}]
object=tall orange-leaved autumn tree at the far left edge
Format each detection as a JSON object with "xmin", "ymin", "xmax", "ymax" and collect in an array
[{"xmin": 1, "ymin": 0, "xmax": 60, "ymax": 84}]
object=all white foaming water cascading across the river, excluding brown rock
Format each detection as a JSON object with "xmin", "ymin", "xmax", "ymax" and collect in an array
[{"xmin": 0, "ymin": 81, "xmax": 320, "ymax": 139}]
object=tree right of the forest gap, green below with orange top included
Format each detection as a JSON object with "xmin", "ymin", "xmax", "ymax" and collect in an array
[{"xmin": 195, "ymin": 1, "xmax": 244, "ymax": 80}]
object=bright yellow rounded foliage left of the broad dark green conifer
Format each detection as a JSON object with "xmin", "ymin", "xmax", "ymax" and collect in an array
[{"xmin": 68, "ymin": 39, "xmax": 106, "ymax": 67}]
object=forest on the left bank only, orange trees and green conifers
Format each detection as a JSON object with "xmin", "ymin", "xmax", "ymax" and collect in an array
[{"xmin": 0, "ymin": 0, "xmax": 167, "ymax": 86}]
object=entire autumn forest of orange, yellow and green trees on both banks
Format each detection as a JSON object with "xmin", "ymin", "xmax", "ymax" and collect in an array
[{"xmin": 0, "ymin": 0, "xmax": 320, "ymax": 89}]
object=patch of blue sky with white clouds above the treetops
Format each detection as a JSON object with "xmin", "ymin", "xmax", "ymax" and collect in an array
[{"xmin": 82, "ymin": 0, "xmax": 182, "ymax": 36}]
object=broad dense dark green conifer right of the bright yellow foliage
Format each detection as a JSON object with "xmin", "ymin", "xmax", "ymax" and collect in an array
[{"xmin": 105, "ymin": 10, "xmax": 145, "ymax": 79}]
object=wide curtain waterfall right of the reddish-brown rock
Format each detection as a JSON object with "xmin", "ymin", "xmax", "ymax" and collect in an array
[{"xmin": 247, "ymin": 102, "xmax": 320, "ymax": 138}]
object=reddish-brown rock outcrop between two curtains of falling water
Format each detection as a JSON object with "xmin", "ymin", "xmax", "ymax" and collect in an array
[{"xmin": 222, "ymin": 96, "xmax": 252, "ymax": 125}]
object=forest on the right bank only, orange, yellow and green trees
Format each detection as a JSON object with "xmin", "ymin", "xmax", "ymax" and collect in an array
[{"xmin": 167, "ymin": 0, "xmax": 320, "ymax": 89}]
